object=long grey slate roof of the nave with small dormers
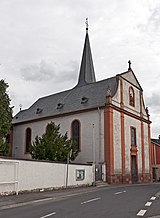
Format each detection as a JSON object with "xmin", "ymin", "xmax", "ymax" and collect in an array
[{"xmin": 12, "ymin": 76, "xmax": 118, "ymax": 124}]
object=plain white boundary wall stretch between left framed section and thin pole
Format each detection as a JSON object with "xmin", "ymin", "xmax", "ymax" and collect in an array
[{"xmin": 18, "ymin": 161, "xmax": 66, "ymax": 190}]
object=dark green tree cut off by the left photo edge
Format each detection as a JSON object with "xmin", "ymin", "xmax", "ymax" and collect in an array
[{"xmin": 0, "ymin": 80, "xmax": 12, "ymax": 156}]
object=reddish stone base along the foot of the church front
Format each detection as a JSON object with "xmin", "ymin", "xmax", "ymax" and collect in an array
[{"xmin": 107, "ymin": 173, "xmax": 152, "ymax": 184}]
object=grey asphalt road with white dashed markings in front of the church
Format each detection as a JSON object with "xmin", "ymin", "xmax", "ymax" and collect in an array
[{"xmin": 0, "ymin": 184, "xmax": 160, "ymax": 218}]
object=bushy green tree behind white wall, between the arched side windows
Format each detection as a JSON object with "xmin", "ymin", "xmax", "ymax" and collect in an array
[{"xmin": 30, "ymin": 122, "xmax": 78, "ymax": 162}]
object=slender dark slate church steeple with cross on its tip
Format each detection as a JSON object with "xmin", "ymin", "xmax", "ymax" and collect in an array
[{"xmin": 77, "ymin": 18, "xmax": 96, "ymax": 86}]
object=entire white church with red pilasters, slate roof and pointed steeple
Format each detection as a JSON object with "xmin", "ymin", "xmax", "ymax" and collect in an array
[{"xmin": 12, "ymin": 26, "xmax": 152, "ymax": 184}]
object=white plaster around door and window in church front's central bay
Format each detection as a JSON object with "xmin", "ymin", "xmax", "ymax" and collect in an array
[{"xmin": 125, "ymin": 115, "xmax": 142, "ymax": 173}]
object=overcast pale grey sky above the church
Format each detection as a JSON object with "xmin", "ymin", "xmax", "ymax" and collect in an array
[{"xmin": 0, "ymin": 0, "xmax": 160, "ymax": 137}]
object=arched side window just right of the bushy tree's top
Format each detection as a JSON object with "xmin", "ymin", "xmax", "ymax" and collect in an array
[{"xmin": 71, "ymin": 120, "xmax": 80, "ymax": 150}]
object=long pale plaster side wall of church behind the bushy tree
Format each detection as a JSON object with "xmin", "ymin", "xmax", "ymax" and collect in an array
[{"xmin": 12, "ymin": 110, "xmax": 104, "ymax": 163}]
